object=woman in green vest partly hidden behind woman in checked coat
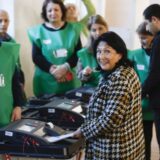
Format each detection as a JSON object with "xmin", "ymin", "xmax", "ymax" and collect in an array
[{"xmin": 77, "ymin": 15, "xmax": 108, "ymax": 87}]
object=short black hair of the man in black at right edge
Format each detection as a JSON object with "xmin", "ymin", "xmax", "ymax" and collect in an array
[{"xmin": 143, "ymin": 4, "xmax": 160, "ymax": 21}]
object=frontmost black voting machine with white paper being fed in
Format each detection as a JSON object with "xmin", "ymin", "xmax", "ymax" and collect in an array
[{"xmin": 0, "ymin": 119, "xmax": 84, "ymax": 159}]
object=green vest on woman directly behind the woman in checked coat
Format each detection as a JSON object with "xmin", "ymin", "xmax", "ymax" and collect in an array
[{"xmin": 77, "ymin": 48, "xmax": 100, "ymax": 87}]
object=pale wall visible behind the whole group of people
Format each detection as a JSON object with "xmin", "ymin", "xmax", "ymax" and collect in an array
[{"xmin": 0, "ymin": 0, "xmax": 160, "ymax": 96}]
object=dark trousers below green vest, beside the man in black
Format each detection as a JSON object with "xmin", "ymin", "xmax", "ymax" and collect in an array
[{"xmin": 143, "ymin": 120, "xmax": 153, "ymax": 160}]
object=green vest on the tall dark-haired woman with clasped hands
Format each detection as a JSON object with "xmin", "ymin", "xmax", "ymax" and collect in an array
[{"xmin": 28, "ymin": 23, "xmax": 79, "ymax": 96}]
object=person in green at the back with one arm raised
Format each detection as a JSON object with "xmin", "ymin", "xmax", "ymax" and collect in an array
[{"xmin": 65, "ymin": 0, "xmax": 96, "ymax": 37}]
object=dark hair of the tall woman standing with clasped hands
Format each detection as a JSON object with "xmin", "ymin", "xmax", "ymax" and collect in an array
[{"xmin": 41, "ymin": 0, "xmax": 66, "ymax": 22}]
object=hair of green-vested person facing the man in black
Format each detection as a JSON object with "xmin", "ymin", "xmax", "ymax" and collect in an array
[{"xmin": 136, "ymin": 21, "xmax": 153, "ymax": 36}]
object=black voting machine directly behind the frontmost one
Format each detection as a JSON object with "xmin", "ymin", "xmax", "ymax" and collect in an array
[{"xmin": 22, "ymin": 97, "xmax": 84, "ymax": 130}]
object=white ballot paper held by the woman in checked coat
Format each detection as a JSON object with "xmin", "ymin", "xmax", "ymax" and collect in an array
[{"xmin": 45, "ymin": 132, "xmax": 74, "ymax": 143}]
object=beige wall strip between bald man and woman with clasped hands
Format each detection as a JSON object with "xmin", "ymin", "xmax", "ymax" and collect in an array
[{"xmin": 14, "ymin": 0, "xmax": 43, "ymax": 96}]
